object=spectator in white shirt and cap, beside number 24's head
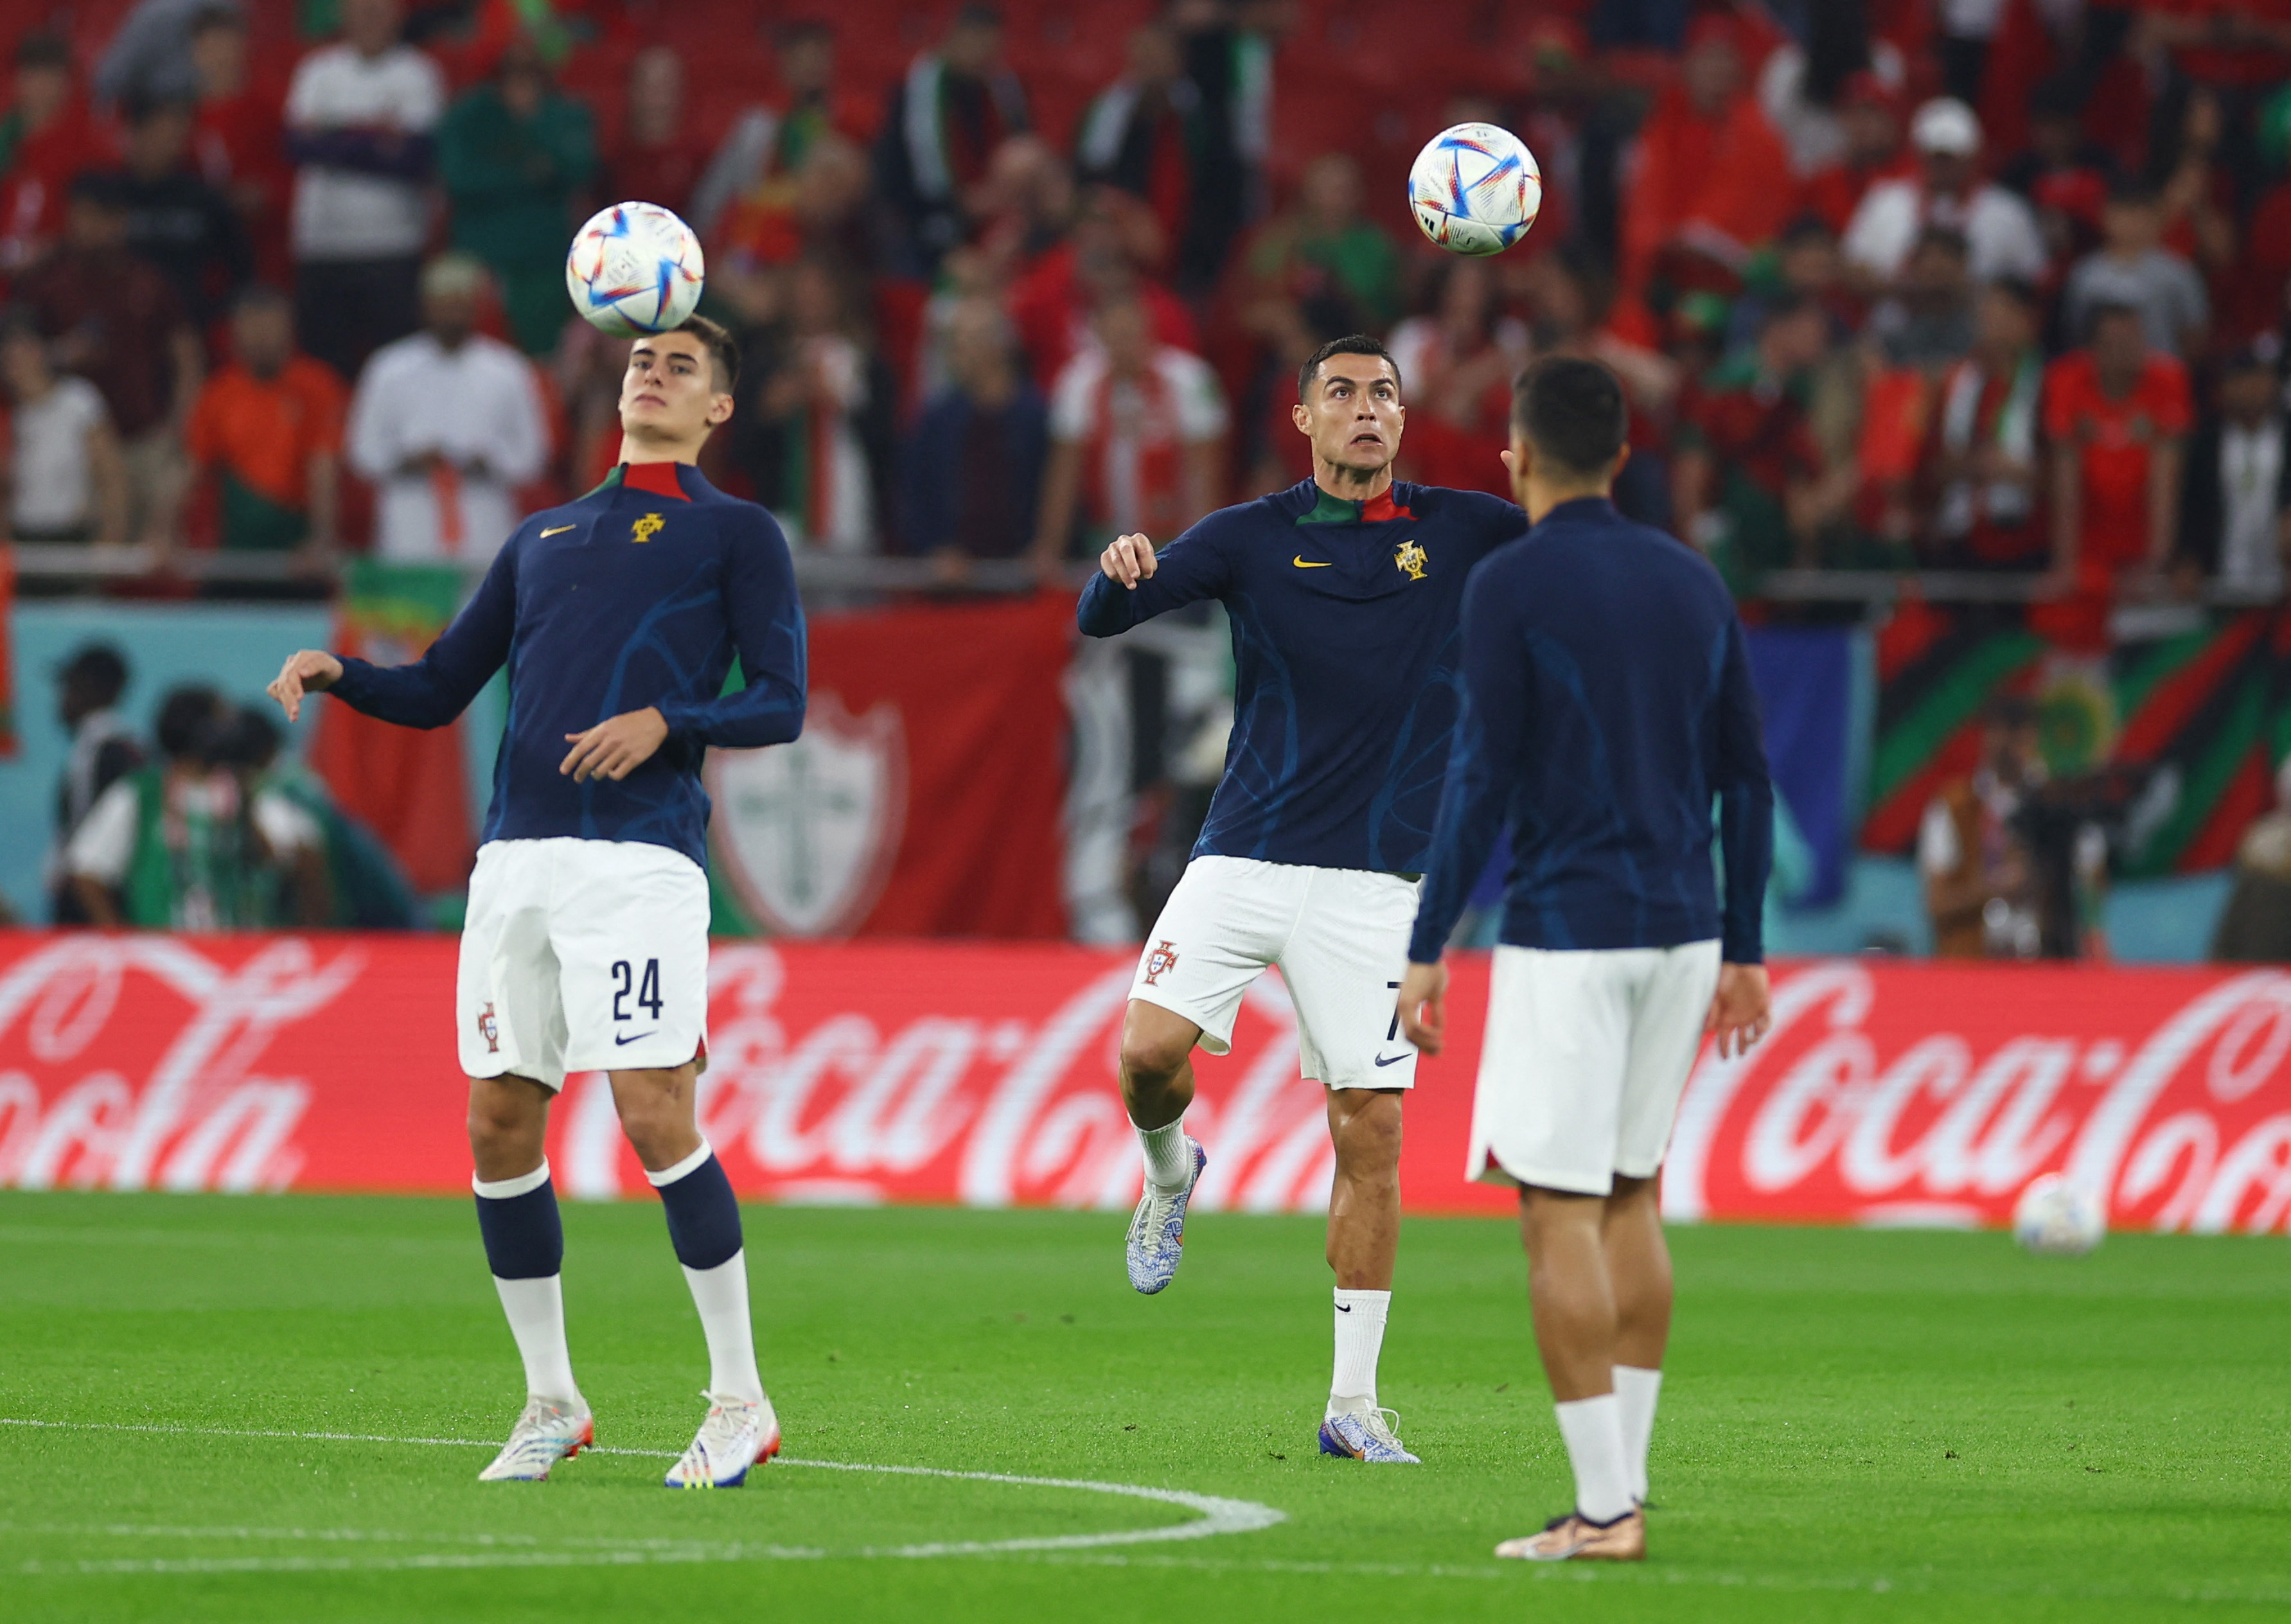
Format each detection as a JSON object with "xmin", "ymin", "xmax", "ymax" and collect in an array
[{"xmin": 348, "ymin": 254, "xmax": 550, "ymax": 563}]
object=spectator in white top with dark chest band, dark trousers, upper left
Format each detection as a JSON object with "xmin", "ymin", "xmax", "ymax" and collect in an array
[{"xmin": 287, "ymin": 0, "xmax": 445, "ymax": 378}]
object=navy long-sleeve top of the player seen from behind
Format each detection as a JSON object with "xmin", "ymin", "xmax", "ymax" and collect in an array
[{"xmin": 1409, "ymin": 497, "xmax": 1773, "ymax": 964}]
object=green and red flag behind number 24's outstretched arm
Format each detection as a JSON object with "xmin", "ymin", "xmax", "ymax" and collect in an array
[{"xmin": 312, "ymin": 559, "xmax": 477, "ymax": 894}]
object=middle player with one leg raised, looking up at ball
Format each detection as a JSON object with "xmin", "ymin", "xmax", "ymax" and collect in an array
[{"xmin": 1079, "ymin": 337, "xmax": 1526, "ymax": 1461}]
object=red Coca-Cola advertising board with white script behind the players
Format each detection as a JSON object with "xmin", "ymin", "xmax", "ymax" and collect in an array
[{"xmin": 0, "ymin": 932, "xmax": 2291, "ymax": 1232}]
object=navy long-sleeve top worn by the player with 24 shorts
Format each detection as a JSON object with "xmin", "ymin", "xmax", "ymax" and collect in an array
[{"xmin": 332, "ymin": 463, "xmax": 804, "ymax": 868}]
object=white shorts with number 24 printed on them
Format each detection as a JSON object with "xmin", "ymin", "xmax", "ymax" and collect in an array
[{"xmin": 454, "ymin": 838, "xmax": 708, "ymax": 1088}]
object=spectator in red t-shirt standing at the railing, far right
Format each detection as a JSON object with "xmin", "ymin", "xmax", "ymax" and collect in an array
[{"xmin": 2044, "ymin": 304, "xmax": 2195, "ymax": 588}]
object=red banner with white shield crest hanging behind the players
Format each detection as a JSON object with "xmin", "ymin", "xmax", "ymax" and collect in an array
[{"xmin": 708, "ymin": 593, "xmax": 1074, "ymax": 939}]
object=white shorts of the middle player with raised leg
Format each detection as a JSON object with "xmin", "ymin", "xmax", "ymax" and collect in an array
[{"xmin": 1129, "ymin": 857, "xmax": 1418, "ymax": 1088}]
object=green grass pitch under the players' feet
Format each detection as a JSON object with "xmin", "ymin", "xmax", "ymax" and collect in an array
[{"xmin": 0, "ymin": 1194, "xmax": 2291, "ymax": 1624}]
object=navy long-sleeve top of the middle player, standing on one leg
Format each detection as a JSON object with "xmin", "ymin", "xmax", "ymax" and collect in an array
[{"xmin": 1077, "ymin": 479, "xmax": 1528, "ymax": 872}]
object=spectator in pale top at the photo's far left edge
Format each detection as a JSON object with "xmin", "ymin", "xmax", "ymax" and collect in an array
[{"xmin": 0, "ymin": 319, "xmax": 128, "ymax": 543}]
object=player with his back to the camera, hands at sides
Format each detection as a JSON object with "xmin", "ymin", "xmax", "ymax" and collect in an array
[{"xmin": 1400, "ymin": 357, "xmax": 1773, "ymax": 1562}]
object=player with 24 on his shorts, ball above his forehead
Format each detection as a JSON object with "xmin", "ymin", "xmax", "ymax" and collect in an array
[{"xmin": 270, "ymin": 319, "xmax": 804, "ymax": 1489}]
